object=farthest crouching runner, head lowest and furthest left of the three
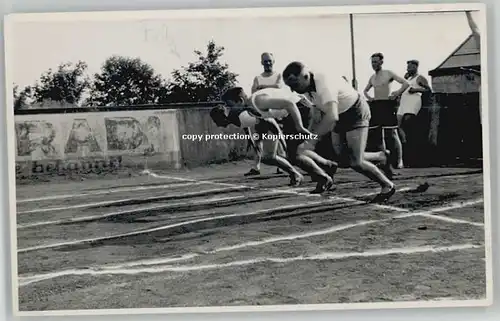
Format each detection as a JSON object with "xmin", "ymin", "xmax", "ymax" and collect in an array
[{"xmin": 210, "ymin": 103, "xmax": 304, "ymax": 186}]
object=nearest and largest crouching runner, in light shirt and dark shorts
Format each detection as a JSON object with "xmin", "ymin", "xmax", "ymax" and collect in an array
[{"xmin": 283, "ymin": 62, "xmax": 396, "ymax": 202}]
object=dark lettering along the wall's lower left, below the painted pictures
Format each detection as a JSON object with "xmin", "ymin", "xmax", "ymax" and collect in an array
[{"xmin": 16, "ymin": 157, "xmax": 122, "ymax": 177}]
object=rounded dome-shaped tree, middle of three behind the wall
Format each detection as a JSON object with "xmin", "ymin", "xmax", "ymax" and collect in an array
[{"xmin": 87, "ymin": 56, "xmax": 167, "ymax": 106}]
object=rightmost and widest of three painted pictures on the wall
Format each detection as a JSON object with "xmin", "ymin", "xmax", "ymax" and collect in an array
[{"xmin": 105, "ymin": 116, "xmax": 160, "ymax": 154}]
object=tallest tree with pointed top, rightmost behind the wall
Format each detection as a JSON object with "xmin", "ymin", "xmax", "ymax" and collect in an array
[{"xmin": 168, "ymin": 41, "xmax": 238, "ymax": 102}]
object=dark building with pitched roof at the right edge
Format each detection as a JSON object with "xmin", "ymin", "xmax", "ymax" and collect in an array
[{"xmin": 428, "ymin": 35, "xmax": 482, "ymax": 164}]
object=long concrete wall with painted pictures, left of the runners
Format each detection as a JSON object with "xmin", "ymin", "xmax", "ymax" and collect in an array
[{"xmin": 15, "ymin": 107, "xmax": 251, "ymax": 177}]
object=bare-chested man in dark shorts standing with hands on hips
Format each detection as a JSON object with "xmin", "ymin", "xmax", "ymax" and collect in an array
[{"xmin": 363, "ymin": 52, "xmax": 409, "ymax": 168}]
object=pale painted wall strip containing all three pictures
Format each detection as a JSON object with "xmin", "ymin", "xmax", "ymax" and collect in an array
[{"xmin": 16, "ymin": 112, "xmax": 170, "ymax": 161}]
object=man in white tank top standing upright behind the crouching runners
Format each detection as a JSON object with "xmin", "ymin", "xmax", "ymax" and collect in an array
[{"xmin": 245, "ymin": 52, "xmax": 285, "ymax": 176}]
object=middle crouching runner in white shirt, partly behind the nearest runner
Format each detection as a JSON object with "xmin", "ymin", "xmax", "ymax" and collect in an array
[{"xmin": 221, "ymin": 87, "xmax": 337, "ymax": 193}]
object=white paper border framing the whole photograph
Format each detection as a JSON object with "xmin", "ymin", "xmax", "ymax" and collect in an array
[{"xmin": 4, "ymin": 3, "xmax": 493, "ymax": 317}]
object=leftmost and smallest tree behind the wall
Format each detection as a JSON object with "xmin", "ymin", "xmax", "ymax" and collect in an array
[{"xmin": 32, "ymin": 61, "xmax": 88, "ymax": 105}]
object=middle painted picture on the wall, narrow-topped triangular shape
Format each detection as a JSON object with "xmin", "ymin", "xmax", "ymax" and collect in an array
[{"xmin": 64, "ymin": 119, "xmax": 102, "ymax": 156}]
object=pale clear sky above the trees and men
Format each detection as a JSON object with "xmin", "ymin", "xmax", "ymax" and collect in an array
[{"xmin": 9, "ymin": 12, "xmax": 481, "ymax": 97}]
